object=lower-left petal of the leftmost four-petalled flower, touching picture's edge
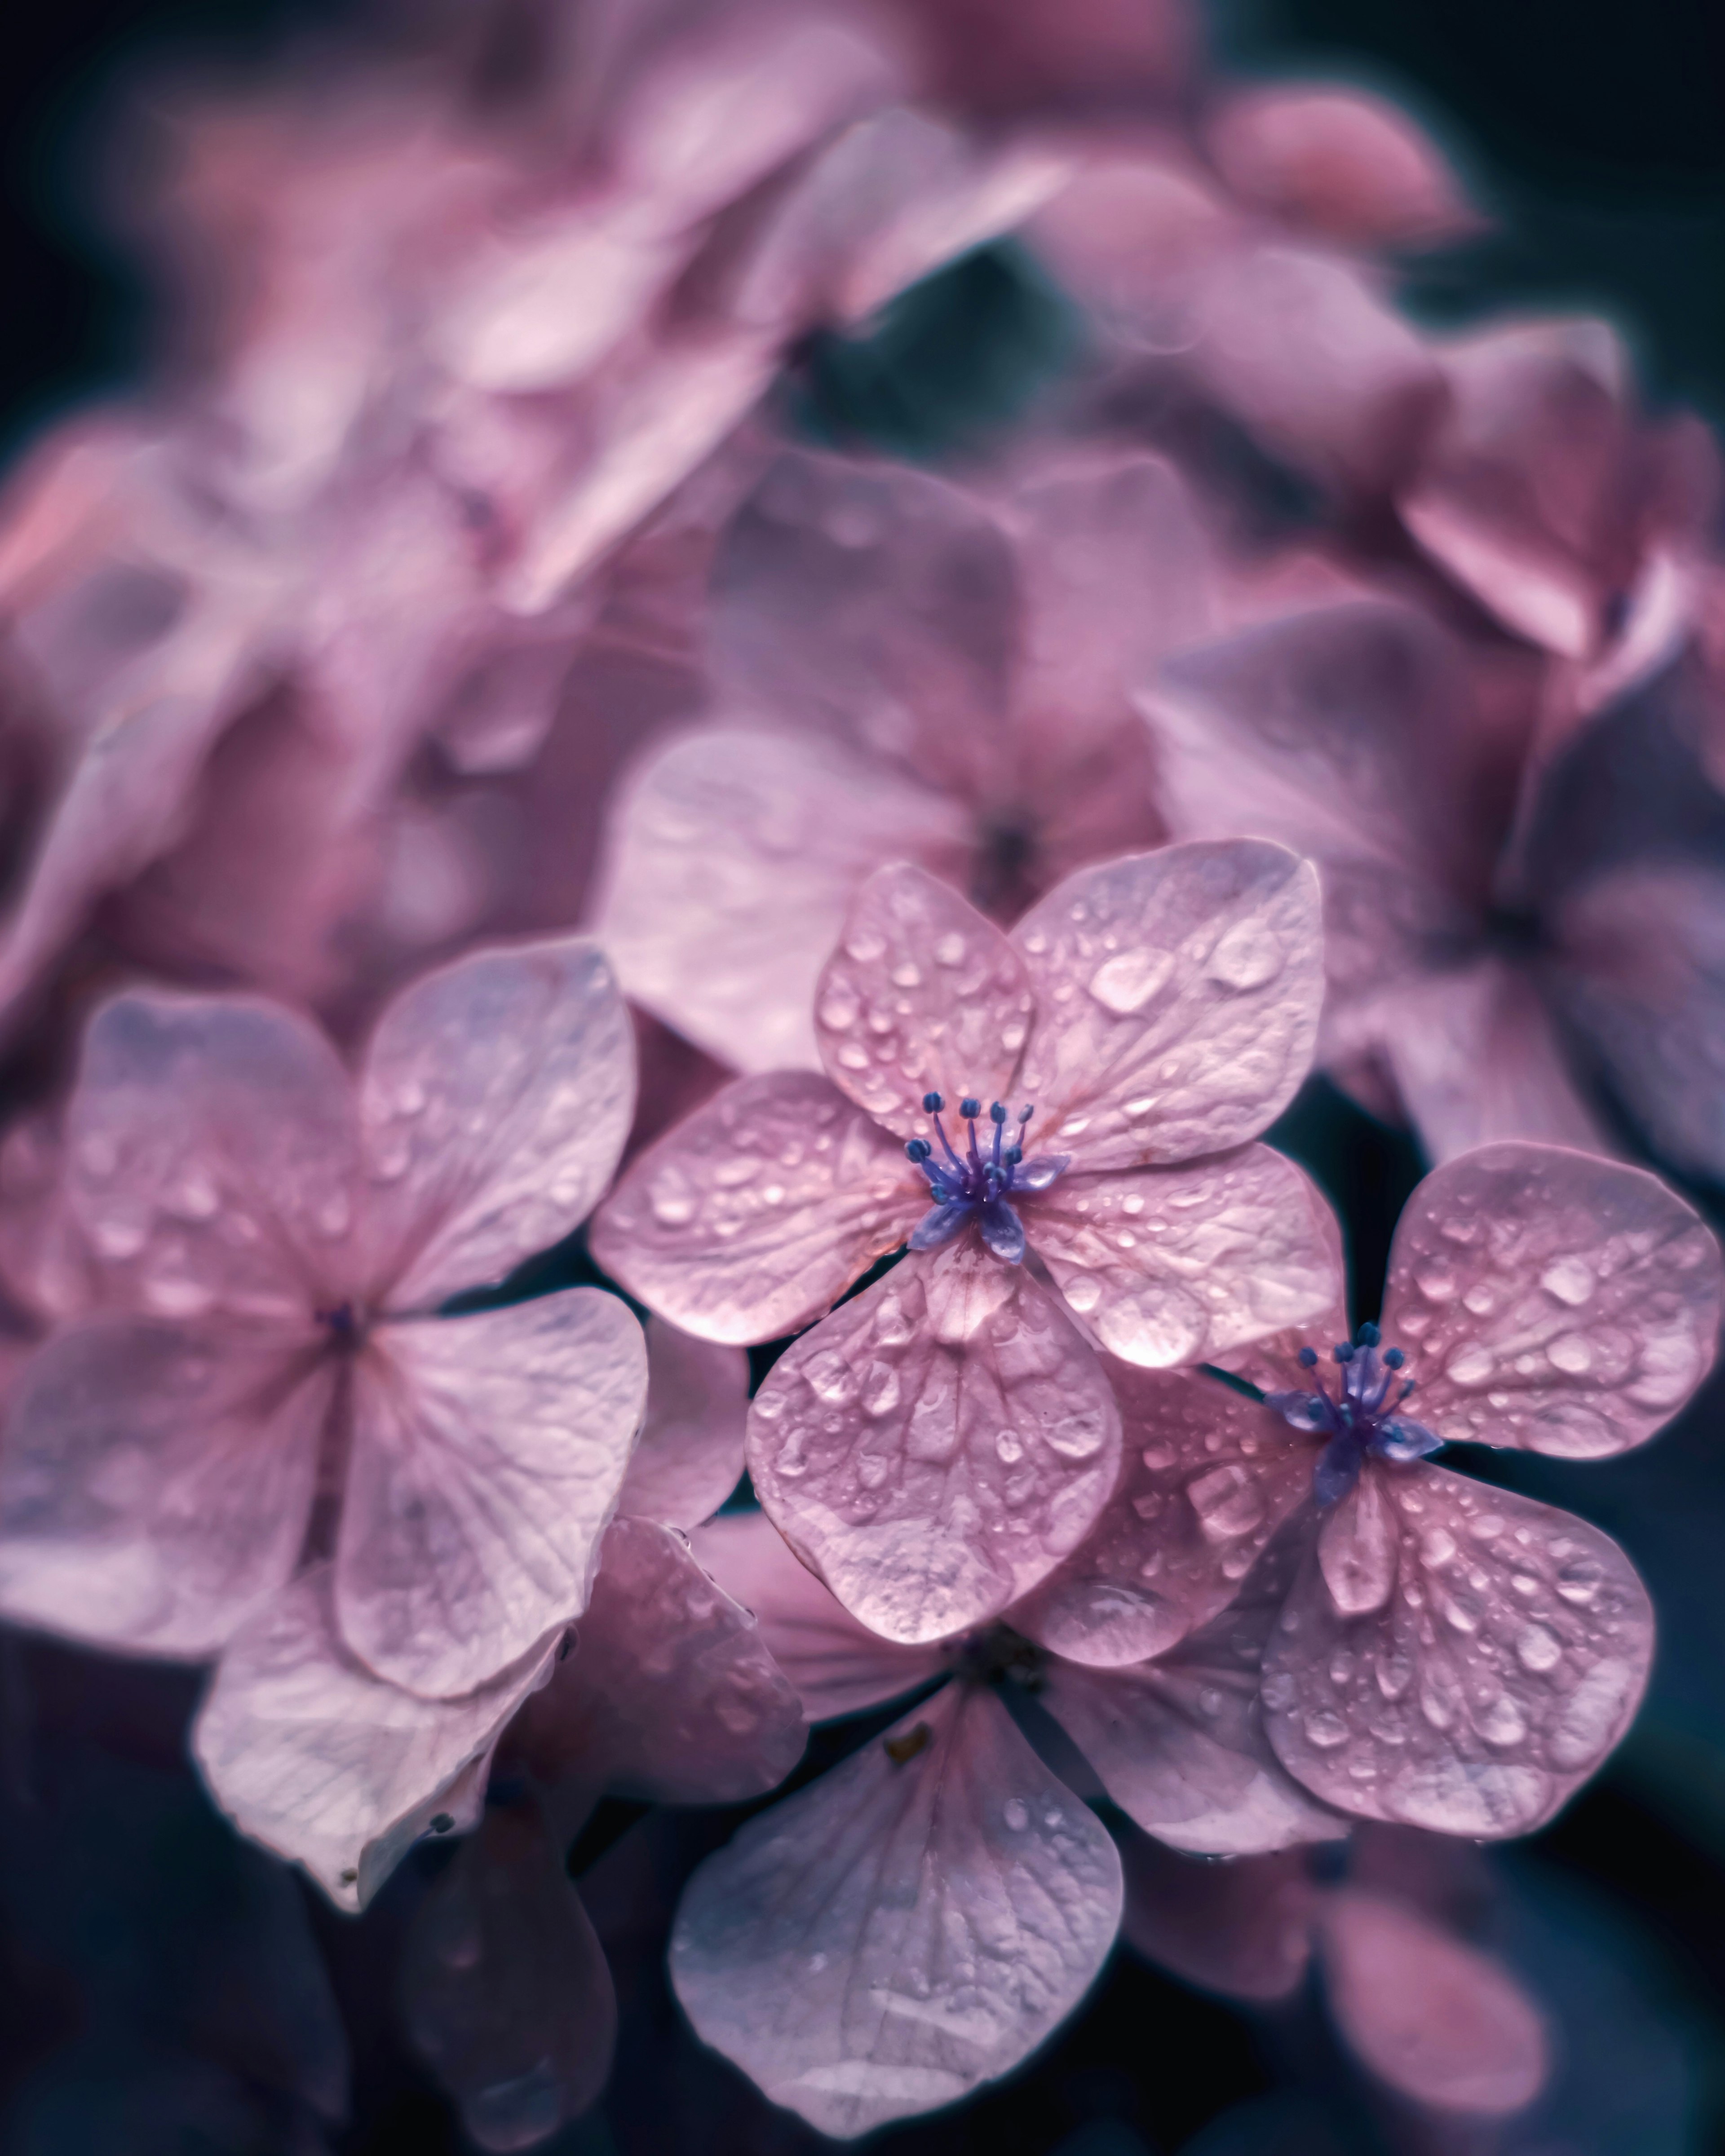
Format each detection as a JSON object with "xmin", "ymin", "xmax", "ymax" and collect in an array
[{"xmin": 0, "ymin": 1317, "xmax": 334, "ymax": 1656}]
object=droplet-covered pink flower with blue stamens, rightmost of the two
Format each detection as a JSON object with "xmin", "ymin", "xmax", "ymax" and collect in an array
[{"xmin": 1022, "ymin": 1143, "xmax": 1721, "ymax": 1837}]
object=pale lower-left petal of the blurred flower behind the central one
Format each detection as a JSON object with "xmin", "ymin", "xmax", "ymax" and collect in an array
[{"xmin": 597, "ymin": 727, "xmax": 968, "ymax": 1072}]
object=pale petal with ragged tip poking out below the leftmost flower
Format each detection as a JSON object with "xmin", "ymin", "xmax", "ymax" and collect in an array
[{"xmin": 192, "ymin": 1565, "xmax": 558, "ymax": 1910}]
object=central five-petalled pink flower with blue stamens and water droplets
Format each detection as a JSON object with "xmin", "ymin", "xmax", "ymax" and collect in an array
[{"xmin": 593, "ymin": 841, "xmax": 1337, "ymax": 1641}]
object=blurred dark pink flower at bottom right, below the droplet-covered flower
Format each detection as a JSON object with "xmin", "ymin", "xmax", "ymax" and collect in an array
[{"xmin": 1121, "ymin": 1826, "xmax": 1552, "ymax": 2119}]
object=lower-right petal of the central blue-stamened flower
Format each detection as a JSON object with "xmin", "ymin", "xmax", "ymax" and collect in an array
[{"xmin": 1024, "ymin": 1140, "xmax": 1343, "ymax": 1369}]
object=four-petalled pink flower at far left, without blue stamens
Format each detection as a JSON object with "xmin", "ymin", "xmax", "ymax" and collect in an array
[{"xmin": 0, "ymin": 940, "xmax": 647, "ymax": 1697}]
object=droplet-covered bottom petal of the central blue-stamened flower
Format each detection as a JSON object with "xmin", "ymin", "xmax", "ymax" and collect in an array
[{"xmin": 748, "ymin": 1235, "xmax": 1119, "ymax": 1645}]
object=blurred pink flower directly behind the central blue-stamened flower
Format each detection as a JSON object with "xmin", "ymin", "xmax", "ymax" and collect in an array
[{"xmin": 597, "ymin": 451, "xmax": 1218, "ymax": 1072}]
